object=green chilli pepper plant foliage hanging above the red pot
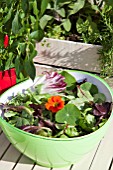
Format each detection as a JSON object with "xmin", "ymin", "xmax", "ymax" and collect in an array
[{"xmin": 0, "ymin": 0, "xmax": 48, "ymax": 79}]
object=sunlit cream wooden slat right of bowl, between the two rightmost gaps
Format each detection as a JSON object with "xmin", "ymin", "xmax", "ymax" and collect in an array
[{"xmin": 90, "ymin": 123, "xmax": 113, "ymax": 170}]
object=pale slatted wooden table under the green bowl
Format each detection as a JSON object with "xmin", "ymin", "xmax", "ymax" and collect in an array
[{"xmin": 0, "ymin": 65, "xmax": 113, "ymax": 170}]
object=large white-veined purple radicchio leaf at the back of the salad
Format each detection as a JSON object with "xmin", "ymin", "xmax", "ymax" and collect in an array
[{"xmin": 36, "ymin": 72, "xmax": 67, "ymax": 94}]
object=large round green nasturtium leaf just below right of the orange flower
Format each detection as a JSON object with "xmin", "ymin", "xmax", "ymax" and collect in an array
[{"xmin": 55, "ymin": 104, "xmax": 81, "ymax": 125}]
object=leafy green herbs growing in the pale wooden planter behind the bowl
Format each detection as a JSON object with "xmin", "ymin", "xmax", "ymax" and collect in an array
[{"xmin": 40, "ymin": 0, "xmax": 113, "ymax": 76}]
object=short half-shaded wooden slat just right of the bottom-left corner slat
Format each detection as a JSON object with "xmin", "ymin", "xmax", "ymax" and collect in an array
[{"xmin": 14, "ymin": 155, "xmax": 34, "ymax": 170}]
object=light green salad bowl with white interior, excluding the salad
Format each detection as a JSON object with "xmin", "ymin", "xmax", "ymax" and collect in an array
[{"xmin": 0, "ymin": 71, "xmax": 113, "ymax": 168}]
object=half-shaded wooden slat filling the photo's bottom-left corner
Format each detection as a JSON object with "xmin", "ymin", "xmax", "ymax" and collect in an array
[{"xmin": 0, "ymin": 145, "xmax": 20, "ymax": 170}]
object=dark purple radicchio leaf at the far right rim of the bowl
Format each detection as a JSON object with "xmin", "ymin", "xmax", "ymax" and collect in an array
[{"xmin": 93, "ymin": 102, "xmax": 111, "ymax": 117}]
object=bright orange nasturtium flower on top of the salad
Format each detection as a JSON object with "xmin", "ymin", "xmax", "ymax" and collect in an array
[{"xmin": 45, "ymin": 96, "xmax": 64, "ymax": 113}]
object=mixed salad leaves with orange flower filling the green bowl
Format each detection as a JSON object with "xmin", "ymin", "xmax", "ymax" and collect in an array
[{"xmin": 2, "ymin": 71, "xmax": 112, "ymax": 138}]
